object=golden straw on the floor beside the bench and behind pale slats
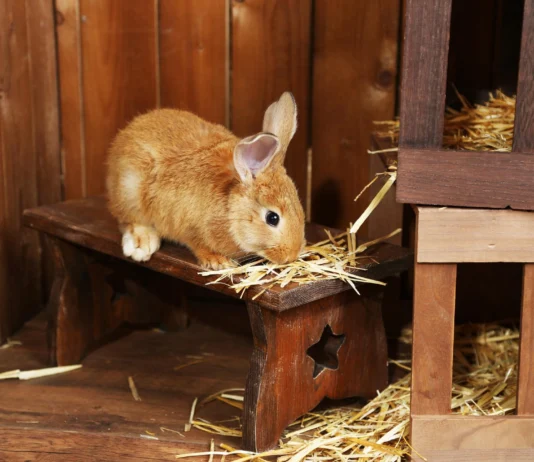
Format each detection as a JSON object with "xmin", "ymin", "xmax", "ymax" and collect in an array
[{"xmin": 177, "ymin": 325, "xmax": 519, "ymax": 462}]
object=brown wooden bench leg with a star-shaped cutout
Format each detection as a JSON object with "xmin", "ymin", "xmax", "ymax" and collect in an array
[{"xmin": 243, "ymin": 288, "xmax": 387, "ymax": 451}]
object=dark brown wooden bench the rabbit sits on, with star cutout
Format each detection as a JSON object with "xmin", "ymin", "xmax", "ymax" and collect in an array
[{"xmin": 24, "ymin": 198, "xmax": 412, "ymax": 451}]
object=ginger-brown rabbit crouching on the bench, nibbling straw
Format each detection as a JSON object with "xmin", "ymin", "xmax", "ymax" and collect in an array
[{"xmin": 107, "ymin": 92, "xmax": 305, "ymax": 269}]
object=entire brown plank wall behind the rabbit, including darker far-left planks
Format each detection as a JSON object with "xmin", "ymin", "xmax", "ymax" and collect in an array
[{"xmin": 0, "ymin": 0, "xmax": 401, "ymax": 342}]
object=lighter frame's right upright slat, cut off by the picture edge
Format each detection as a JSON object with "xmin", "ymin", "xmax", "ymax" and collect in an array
[{"xmin": 517, "ymin": 264, "xmax": 534, "ymax": 415}]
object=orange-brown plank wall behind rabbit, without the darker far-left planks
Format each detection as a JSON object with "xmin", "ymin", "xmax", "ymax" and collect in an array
[{"xmin": 58, "ymin": 0, "xmax": 400, "ymax": 226}]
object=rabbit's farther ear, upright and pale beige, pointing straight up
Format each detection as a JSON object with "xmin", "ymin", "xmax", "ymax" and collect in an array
[{"xmin": 263, "ymin": 91, "xmax": 297, "ymax": 163}]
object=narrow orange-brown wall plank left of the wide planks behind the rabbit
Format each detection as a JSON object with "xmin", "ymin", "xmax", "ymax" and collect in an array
[{"xmin": 56, "ymin": 0, "xmax": 87, "ymax": 199}]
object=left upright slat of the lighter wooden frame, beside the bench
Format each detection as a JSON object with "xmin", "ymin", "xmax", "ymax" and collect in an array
[{"xmin": 411, "ymin": 263, "xmax": 456, "ymax": 416}]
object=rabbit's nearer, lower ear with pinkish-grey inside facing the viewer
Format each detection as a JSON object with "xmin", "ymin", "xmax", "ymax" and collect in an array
[{"xmin": 234, "ymin": 133, "xmax": 280, "ymax": 181}]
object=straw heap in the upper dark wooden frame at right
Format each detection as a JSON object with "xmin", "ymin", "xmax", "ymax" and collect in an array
[{"xmin": 370, "ymin": 90, "xmax": 516, "ymax": 154}]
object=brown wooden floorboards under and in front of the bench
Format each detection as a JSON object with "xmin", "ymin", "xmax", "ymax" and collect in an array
[{"xmin": 0, "ymin": 304, "xmax": 252, "ymax": 462}]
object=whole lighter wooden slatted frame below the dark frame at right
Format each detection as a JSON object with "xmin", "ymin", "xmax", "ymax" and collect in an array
[{"xmin": 411, "ymin": 207, "xmax": 534, "ymax": 462}]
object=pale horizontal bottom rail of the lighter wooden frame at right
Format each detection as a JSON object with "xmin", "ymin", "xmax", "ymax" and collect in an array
[{"xmin": 411, "ymin": 415, "xmax": 534, "ymax": 462}]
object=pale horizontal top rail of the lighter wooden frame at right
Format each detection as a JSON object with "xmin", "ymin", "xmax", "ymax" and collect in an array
[{"xmin": 416, "ymin": 207, "xmax": 534, "ymax": 263}]
